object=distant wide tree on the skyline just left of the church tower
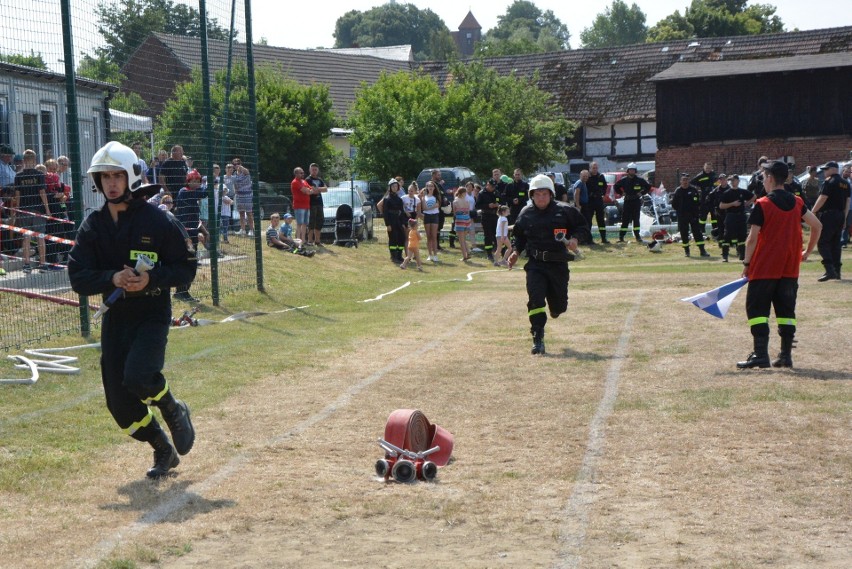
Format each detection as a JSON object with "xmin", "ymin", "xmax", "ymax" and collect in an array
[{"xmin": 334, "ymin": 2, "xmax": 455, "ymax": 61}]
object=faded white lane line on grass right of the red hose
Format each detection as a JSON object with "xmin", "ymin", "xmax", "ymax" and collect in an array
[{"xmin": 554, "ymin": 291, "xmax": 644, "ymax": 569}]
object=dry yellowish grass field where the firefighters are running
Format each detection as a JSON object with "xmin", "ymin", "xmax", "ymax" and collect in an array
[{"xmin": 0, "ymin": 237, "xmax": 852, "ymax": 569}]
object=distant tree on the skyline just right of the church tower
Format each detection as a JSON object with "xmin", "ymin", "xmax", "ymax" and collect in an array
[{"xmin": 477, "ymin": 0, "xmax": 571, "ymax": 57}]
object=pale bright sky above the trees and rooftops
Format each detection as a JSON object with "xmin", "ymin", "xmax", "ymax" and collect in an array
[{"xmin": 0, "ymin": 0, "xmax": 852, "ymax": 73}]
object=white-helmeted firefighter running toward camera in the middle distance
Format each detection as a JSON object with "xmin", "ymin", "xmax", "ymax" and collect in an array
[{"xmin": 509, "ymin": 174, "xmax": 589, "ymax": 354}]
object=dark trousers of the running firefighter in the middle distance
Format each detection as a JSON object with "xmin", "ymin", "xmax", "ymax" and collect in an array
[{"xmin": 524, "ymin": 258, "xmax": 570, "ymax": 329}]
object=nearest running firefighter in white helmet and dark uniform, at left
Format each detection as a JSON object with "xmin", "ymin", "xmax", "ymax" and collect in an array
[{"xmin": 68, "ymin": 142, "xmax": 197, "ymax": 479}]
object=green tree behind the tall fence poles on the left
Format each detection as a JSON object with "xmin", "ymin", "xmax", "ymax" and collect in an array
[{"xmin": 155, "ymin": 65, "xmax": 334, "ymax": 182}]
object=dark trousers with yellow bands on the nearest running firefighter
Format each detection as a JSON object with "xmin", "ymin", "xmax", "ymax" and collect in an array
[{"xmin": 101, "ymin": 300, "xmax": 171, "ymax": 442}]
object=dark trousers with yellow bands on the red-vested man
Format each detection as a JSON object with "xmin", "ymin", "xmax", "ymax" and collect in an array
[{"xmin": 746, "ymin": 278, "xmax": 799, "ymax": 341}]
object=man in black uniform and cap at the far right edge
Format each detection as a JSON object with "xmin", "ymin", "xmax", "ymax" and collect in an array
[{"xmin": 814, "ymin": 161, "xmax": 850, "ymax": 283}]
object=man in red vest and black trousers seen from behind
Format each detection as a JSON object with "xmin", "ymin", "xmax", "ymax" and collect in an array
[{"xmin": 737, "ymin": 160, "xmax": 822, "ymax": 369}]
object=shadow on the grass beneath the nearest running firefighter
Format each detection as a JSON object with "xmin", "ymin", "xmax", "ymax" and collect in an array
[{"xmin": 101, "ymin": 478, "xmax": 236, "ymax": 523}]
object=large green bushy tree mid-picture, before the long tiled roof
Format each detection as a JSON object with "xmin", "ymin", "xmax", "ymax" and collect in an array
[{"xmin": 350, "ymin": 63, "xmax": 574, "ymax": 179}]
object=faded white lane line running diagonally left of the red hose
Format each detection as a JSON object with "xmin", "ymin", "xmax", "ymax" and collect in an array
[{"xmin": 76, "ymin": 302, "xmax": 494, "ymax": 568}]
